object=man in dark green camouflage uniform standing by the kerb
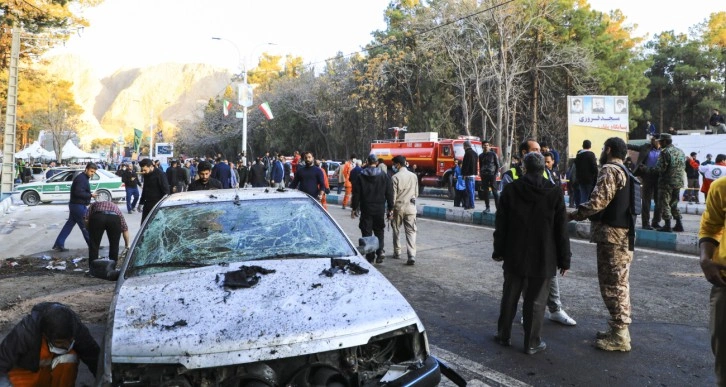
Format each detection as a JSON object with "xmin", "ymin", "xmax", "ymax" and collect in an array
[{"xmin": 649, "ymin": 133, "xmax": 686, "ymax": 232}]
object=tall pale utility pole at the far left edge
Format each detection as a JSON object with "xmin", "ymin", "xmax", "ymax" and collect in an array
[{"xmin": 0, "ymin": 26, "xmax": 20, "ymax": 200}]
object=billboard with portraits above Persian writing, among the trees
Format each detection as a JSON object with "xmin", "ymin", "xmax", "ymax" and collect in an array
[{"xmin": 567, "ymin": 95, "xmax": 630, "ymax": 158}]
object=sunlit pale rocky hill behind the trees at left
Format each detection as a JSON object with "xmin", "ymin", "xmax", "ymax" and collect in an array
[{"xmin": 42, "ymin": 55, "xmax": 232, "ymax": 143}]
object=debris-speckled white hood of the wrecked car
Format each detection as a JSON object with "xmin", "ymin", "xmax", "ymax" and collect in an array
[{"xmin": 111, "ymin": 257, "xmax": 423, "ymax": 368}]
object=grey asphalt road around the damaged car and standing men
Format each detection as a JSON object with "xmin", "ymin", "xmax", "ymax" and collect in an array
[{"xmin": 0, "ymin": 200, "xmax": 715, "ymax": 386}]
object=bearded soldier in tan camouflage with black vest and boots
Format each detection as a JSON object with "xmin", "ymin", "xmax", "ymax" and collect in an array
[{"xmin": 569, "ymin": 137, "xmax": 635, "ymax": 352}]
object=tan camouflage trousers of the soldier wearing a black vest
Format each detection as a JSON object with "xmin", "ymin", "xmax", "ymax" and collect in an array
[{"xmin": 597, "ymin": 242, "xmax": 633, "ymax": 329}]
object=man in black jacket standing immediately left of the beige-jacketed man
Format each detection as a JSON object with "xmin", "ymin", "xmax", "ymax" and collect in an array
[{"xmin": 352, "ymin": 155, "xmax": 393, "ymax": 263}]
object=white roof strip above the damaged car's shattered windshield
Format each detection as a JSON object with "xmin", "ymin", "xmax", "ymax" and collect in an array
[{"xmin": 160, "ymin": 188, "xmax": 310, "ymax": 207}]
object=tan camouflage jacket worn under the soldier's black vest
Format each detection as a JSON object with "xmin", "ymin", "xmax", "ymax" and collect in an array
[{"xmin": 574, "ymin": 159, "xmax": 628, "ymax": 245}]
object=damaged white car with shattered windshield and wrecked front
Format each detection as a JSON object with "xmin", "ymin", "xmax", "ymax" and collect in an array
[{"xmin": 92, "ymin": 189, "xmax": 450, "ymax": 386}]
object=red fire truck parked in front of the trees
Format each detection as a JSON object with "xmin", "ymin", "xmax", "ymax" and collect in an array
[{"xmin": 371, "ymin": 132, "xmax": 483, "ymax": 198}]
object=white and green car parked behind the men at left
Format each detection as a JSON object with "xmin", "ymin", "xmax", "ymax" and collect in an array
[{"xmin": 13, "ymin": 169, "xmax": 126, "ymax": 206}]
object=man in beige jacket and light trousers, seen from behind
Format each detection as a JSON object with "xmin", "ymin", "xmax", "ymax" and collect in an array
[{"xmin": 391, "ymin": 156, "xmax": 418, "ymax": 265}]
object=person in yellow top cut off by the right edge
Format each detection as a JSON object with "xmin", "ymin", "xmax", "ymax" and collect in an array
[{"xmin": 698, "ymin": 178, "xmax": 726, "ymax": 386}]
